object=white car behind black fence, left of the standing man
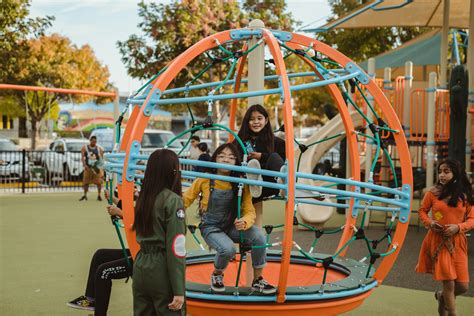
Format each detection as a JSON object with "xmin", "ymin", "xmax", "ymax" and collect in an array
[{"xmin": 42, "ymin": 138, "xmax": 89, "ymax": 182}]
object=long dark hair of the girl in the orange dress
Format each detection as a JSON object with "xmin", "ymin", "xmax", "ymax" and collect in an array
[{"xmin": 436, "ymin": 158, "xmax": 473, "ymax": 207}]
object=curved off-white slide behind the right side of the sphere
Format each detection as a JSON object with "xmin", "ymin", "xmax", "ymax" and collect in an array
[{"xmin": 295, "ymin": 111, "xmax": 365, "ymax": 228}]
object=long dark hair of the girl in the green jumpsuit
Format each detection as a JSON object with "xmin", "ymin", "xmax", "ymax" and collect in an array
[{"xmin": 133, "ymin": 149, "xmax": 182, "ymax": 237}]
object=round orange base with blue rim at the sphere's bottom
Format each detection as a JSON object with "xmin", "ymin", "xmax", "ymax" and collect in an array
[{"xmin": 186, "ymin": 251, "xmax": 377, "ymax": 316}]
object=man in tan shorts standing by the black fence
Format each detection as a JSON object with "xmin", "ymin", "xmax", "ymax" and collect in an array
[{"xmin": 79, "ymin": 136, "xmax": 104, "ymax": 201}]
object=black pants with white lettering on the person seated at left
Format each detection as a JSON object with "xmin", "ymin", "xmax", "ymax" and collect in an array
[{"xmin": 85, "ymin": 249, "xmax": 133, "ymax": 316}]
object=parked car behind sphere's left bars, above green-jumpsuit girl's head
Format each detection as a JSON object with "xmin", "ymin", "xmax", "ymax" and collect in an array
[{"xmin": 91, "ymin": 128, "xmax": 183, "ymax": 154}]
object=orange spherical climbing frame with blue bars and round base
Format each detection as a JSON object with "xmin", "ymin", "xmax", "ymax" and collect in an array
[{"xmin": 113, "ymin": 28, "xmax": 413, "ymax": 316}]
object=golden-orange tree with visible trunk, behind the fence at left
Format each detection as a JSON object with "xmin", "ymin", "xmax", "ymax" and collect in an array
[{"xmin": 15, "ymin": 34, "xmax": 112, "ymax": 148}]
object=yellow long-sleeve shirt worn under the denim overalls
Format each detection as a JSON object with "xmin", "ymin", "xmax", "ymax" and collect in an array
[{"xmin": 183, "ymin": 178, "xmax": 256, "ymax": 230}]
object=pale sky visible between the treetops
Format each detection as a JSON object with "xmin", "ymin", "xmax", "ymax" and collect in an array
[{"xmin": 30, "ymin": 0, "xmax": 331, "ymax": 94}]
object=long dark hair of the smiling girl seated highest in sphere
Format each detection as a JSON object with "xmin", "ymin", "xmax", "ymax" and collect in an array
[{"xmin": 238, "ymin": 104, "xmax": 275, "ymax": 152}]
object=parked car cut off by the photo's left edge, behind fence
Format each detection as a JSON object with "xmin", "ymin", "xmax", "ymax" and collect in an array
[{"xmin": 0, "ymin": 138, "xmax": 30, "ymax": 180}]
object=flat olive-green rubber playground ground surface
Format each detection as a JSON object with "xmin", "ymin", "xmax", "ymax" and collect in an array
[{"xmin": 0, "ymin": 192, "xmax": 474, "ymax": 315}]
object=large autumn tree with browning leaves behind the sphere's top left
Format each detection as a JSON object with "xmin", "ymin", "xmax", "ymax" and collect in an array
[{"xmin": 118, "ymin": 0, "xmax": 297, "ymax": 143}]
